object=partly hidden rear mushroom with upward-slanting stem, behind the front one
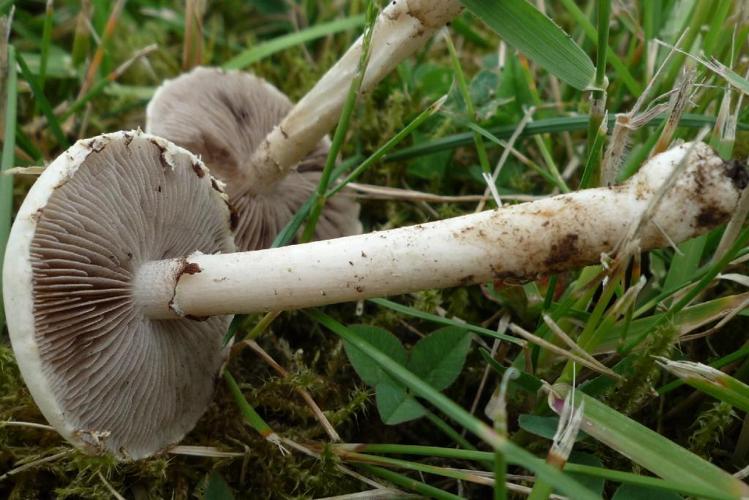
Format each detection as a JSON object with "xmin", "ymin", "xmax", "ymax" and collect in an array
[{"xmin": 146, "ymin": 0, "xmax": 463, "ymax": 250}]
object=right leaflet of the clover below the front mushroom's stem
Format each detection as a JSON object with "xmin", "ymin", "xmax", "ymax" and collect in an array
[{"xmin": 406, "ymin": 326, "xmax": 471, "ymax": 391}]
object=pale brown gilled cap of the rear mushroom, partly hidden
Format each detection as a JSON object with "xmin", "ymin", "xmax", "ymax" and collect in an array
[{"xmin": 146, "ymin": 67, "xmax": 362, "ymax": 250}]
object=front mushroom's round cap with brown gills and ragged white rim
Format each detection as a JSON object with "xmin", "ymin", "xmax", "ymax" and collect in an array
[{"xmin": 3, "ymin": 131, "xmax": 234, "ymax": 459}]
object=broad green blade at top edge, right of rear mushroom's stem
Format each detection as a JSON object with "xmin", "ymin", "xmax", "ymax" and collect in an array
[{"xmin": 461, "ymin": 0, "xmax": 596, "ymax": 90}]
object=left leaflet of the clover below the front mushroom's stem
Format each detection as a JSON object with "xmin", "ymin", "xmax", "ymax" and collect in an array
[{"xmin": 343, "ymin": 325, "xmax": 407, "ymax": 386}]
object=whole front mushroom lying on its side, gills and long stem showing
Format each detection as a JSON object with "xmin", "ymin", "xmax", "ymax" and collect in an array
[{"xmin": 3, "ymin": 132, "xmax": 747, "ymax": 458}]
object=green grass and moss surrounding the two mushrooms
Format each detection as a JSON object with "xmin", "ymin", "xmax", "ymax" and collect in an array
[{"xmin": 0, "ymin": 0, "xmax": 749, "ymax": 499}]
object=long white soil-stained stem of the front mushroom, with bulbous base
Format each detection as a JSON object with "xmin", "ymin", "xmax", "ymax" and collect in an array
[{"xmin": 135, "ymin": 144, "xmax": 746, "ymax": 319}]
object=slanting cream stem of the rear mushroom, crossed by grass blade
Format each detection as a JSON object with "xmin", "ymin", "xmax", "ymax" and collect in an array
[{"xmin": 243, "ymin": 0, "xmax": 462, "ymax": 193}]
